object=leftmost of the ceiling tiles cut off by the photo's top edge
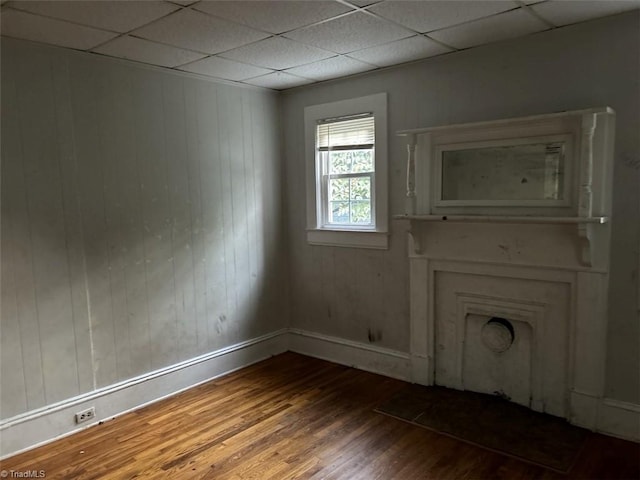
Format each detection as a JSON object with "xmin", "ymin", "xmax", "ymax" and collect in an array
[{"xmin": 6, "ymin": 0, "xmax": 180, "ymax": 33}]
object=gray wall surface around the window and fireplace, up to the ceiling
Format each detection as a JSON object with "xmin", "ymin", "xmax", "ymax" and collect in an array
[{"xmin": 282, "ymin": 11, "xmax": 640, "ymax": 403}]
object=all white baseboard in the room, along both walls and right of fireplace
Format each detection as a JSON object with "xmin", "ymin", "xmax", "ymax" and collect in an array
[{"xmin": 0, "ymin": 328, "xmax": 640, "ymax": 459}]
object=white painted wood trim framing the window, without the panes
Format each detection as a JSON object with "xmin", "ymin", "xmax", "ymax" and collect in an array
[{"xmin": 304, "ymin": 93, "xmax": 389, "ymax": 249}]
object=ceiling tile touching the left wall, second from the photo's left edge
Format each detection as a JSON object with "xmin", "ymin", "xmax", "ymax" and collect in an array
[{"xmin": 93, "ymin": 35, "xmax": 204, "ymax": 67}]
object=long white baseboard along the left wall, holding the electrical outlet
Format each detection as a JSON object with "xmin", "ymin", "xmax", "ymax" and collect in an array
[{"xmin": 0, "ymin": 329, "xmax": 288, "ymax": 459}]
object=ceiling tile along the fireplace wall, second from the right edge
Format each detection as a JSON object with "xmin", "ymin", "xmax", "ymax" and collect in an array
[{"xmin": 429, "ymin": 9, "xmax": 549, "ymax": 48}]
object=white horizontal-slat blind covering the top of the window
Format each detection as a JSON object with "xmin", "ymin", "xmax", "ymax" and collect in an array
[{"xmin": 316, "ymin": 115, "xmax": 375, "ymax": 152}]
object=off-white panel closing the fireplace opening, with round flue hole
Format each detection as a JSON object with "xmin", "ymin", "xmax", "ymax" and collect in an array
[{"xmin": 434, "ymin": 271, "xmax": 571, "ymax": 417}]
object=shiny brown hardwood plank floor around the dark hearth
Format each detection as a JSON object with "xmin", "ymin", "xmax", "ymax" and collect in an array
[{"xmin": 0, "ymin": 353, "xmax": 640, "ymax": 480}]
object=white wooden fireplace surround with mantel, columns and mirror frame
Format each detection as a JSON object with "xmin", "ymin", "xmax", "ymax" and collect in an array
[{"xmin": 395, "ymin": 108, "xmax": 615, "ymax": 429}]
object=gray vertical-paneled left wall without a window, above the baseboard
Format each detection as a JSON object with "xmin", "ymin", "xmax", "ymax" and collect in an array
[{"xmin": 0, "ymin": 38, "xmax": 288, "ymax": 418}]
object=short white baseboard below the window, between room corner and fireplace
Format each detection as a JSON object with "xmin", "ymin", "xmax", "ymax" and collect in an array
[{"xmin": 289, "ymin": 328, "xmax": 411, "ymax": 381}]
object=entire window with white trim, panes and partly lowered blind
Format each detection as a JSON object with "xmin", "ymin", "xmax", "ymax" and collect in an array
[{"xmin": 305, "ymin": 94, "xmax": 388, "ymax": 248}]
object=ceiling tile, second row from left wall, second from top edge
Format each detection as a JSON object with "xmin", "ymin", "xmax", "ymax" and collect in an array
[{"xmin": 132, "ymin": 9, "xmax": 269, "ymax": 53}]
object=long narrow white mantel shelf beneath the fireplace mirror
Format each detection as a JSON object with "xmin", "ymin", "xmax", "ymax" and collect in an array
[{"xmin": 393, "ymin": 214, "xmax": 609, "ymax": 225}]
